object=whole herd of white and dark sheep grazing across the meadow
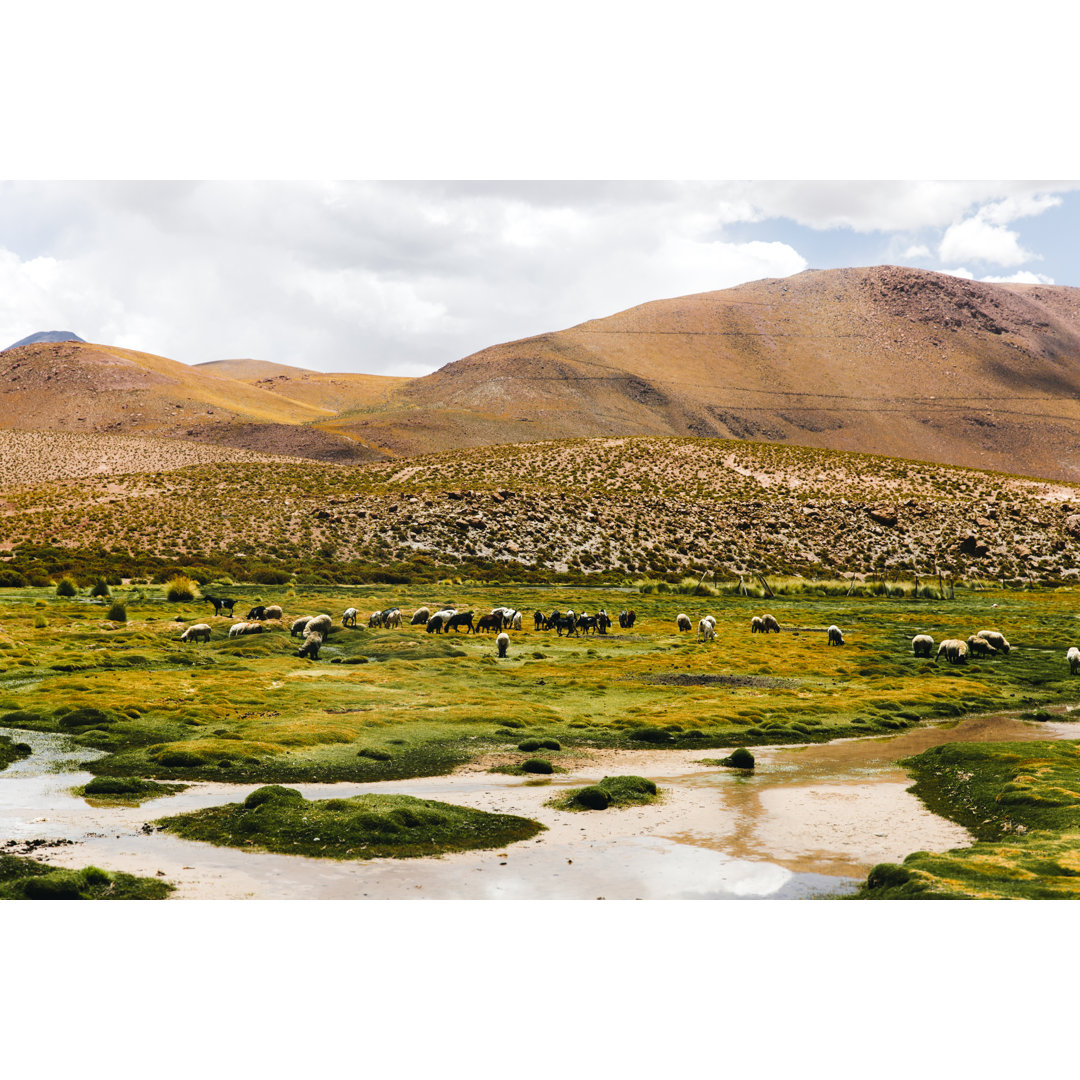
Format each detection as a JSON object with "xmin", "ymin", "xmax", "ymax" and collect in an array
[{"xmin": 170, "ymin": 596, "xmax": 1080, "ymax": 675}]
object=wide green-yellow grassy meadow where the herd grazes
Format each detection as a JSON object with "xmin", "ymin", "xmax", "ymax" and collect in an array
[{"xmin": 0, "ymin": 585, "xmax": 1080, "ymax": 783}]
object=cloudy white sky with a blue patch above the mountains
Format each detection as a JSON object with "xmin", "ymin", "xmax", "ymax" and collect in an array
[{"xmin": 0, "ymin": 179, "xmax": 1080, "ymax": 376}]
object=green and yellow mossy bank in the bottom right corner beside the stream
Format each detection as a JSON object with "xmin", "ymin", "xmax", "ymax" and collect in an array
[{"xmin": 859, "ymin": 741, "xmax": 1080, "ymax": 900}]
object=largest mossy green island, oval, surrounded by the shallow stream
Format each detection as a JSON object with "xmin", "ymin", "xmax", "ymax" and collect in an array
[{"xmin": 154, "ymin": 786, "xmax": 544, "ymax": 859}]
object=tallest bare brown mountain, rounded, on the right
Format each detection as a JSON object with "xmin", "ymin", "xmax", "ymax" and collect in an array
[{"xmin": 332, "ymin": 267, "xmax": 1080, "ymax": 480}]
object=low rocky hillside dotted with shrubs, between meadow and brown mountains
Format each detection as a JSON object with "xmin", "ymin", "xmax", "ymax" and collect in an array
[{"xmin": 0, "ymin": 438, "xmax": 1080, "ymax": 581}]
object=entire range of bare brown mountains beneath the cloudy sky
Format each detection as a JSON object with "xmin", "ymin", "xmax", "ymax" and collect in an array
[{"xmin": 6, "ymin": 267, "xmax": 1080, "ymax": 482}]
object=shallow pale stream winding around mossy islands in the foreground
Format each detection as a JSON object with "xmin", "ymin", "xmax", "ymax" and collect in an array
[{"xmin": 0, "ymin": 708, "xmax": 1080, "ymax": 900}]
